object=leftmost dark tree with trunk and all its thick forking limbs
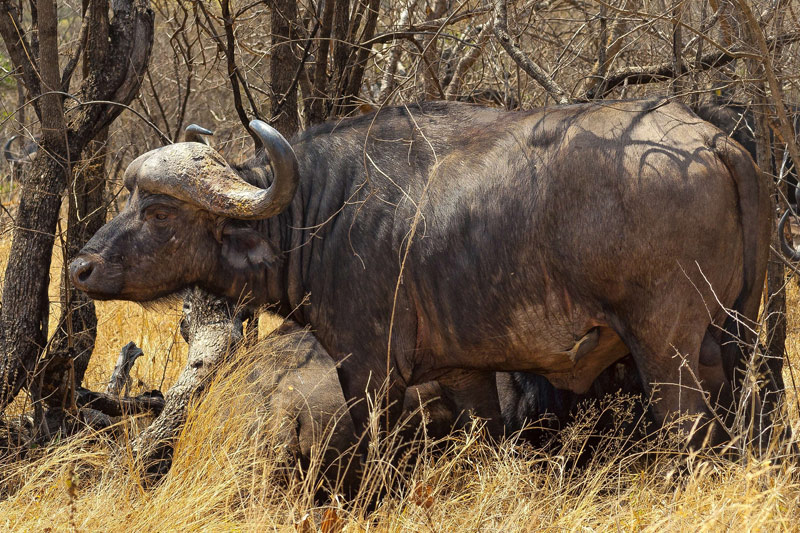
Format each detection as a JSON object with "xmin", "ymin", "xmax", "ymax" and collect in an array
[{"xmin": 0, "ymin": 0, "xmax": 153, "ymax": 410}]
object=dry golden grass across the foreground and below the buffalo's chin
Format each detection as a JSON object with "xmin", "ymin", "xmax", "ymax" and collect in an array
[{"xmin": 0, "ymin": 216, "xmax": 800, "ymax": 532}]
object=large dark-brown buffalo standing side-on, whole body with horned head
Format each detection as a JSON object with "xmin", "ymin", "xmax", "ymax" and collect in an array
[{"xmin": 70, "ymin": 100, "xmax": 771, "ymax": 448}]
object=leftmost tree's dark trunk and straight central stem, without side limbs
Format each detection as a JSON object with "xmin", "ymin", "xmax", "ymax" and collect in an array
[{"xmin": 0, "ymin": 0, "xmax": 70, "ymax": 409}]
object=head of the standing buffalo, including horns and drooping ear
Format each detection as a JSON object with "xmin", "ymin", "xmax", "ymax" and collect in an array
[{"xmin": 69, "ymin": 120, "xmax": 299, "ymax": 301}]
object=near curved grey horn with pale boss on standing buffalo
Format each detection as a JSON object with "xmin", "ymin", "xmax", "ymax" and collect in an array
[{"xmin": 124, "ymin": 120, "xmax": 299, "ymax": 220}]
